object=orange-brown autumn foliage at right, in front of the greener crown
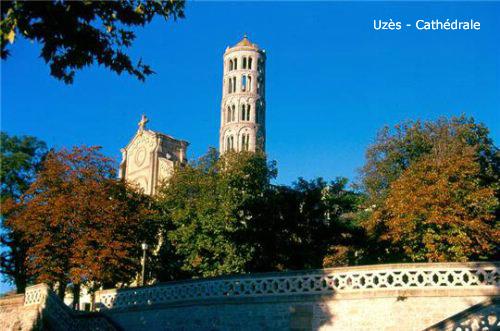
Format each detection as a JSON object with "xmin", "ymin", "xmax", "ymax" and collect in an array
[{"xmin": 372, "ymin": 146, "xmax": 500, "ymax": 262}]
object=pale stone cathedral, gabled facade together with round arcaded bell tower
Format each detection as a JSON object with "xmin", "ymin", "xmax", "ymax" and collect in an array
[{"xmin": 120, "ymin": 35, "xmax": 266, "ymax": 195}]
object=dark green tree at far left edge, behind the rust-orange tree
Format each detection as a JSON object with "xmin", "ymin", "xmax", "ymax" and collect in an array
[{"xmin": 0, "ymin": 132, "xmax": 47, "ymax": 293}]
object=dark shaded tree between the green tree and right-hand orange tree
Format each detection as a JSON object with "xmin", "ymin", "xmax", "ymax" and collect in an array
[{"xmin": 252, "ymin": 178, "xmax": 363, "ymax": 271}]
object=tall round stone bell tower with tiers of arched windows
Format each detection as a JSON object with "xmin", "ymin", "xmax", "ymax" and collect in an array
[{"xmin": 219, "ymin": 35, "xmax": 266, "ymax": 154}]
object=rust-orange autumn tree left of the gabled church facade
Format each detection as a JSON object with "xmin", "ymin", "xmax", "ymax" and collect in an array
[{"xmin": 4, "ymin": 147, "xmax": 151, "ymax": 295}]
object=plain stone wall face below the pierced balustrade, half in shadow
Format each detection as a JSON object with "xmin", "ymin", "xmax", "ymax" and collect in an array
[{"xmin": 99, "ymin": 296, "xmax": 494, "ymax": 331}]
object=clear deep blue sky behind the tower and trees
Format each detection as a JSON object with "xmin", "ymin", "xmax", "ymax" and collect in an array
[{"xmin": 1, "ymin": 2, "xmax": 500, "ymax": 294}]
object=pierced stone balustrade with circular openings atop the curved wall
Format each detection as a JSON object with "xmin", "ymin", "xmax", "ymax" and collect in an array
[{"xmin": 96, "ymin": 262, "xmax": 500, "ymax": 310}]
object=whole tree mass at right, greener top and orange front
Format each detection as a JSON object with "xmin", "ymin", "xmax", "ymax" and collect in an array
[{"xmin": 362, "ymin": 116, "xmax": 500, "ymax": 261}]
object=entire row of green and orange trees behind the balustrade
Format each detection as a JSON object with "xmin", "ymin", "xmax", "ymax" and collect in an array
[{"xmin": 1, "ymin": 116, "xmax": 500, "ymax": 294}]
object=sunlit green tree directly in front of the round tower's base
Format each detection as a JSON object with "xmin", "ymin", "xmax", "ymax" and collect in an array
[{"xmin": 158, "ymin": 150, "xmax": 275, "ymax": 277}]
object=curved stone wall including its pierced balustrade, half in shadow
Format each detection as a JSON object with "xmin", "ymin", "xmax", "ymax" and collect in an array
[{"xmin": 96, "ymin": 263, "xmax": 500, "ymax": 330}]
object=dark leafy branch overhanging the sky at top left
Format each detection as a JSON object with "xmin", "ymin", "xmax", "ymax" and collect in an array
[{"xmin": 0, "ymin": 0, "xmax": 184, "ymax": 84}]
